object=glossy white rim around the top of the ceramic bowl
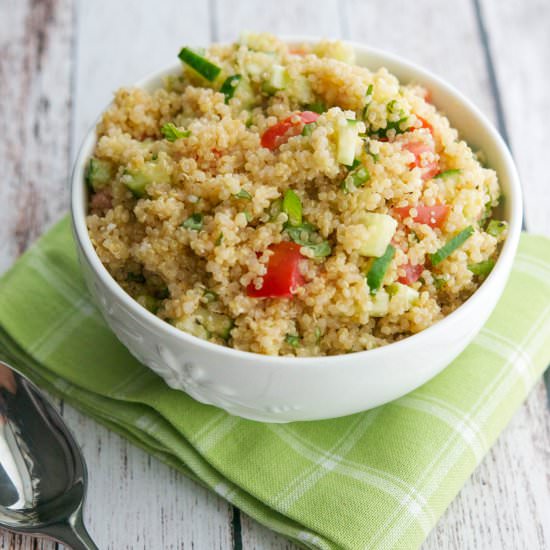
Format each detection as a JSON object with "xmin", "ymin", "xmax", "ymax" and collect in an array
[{"xmin": 70, "ymin": 35, "xmax": 523, "ymax": 368}]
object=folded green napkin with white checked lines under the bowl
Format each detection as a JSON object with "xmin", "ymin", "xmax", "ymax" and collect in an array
[{"xmin": 0, "ymin": 219, "xmax": 550, "ymax": 549}]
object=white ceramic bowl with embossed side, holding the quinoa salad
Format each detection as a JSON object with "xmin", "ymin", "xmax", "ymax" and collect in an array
[{"xmin": 71, "ymin": 37, "xmax": 522, "ymax": 422}]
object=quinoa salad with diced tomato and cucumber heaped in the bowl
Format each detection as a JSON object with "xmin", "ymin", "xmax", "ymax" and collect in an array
[{"xmin": 86, "ymin": 34, "xmax": 507, "ymax": 356}]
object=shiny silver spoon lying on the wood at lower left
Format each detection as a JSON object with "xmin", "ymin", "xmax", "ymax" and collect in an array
[{"xmin": 0, "ymin": 361, "xmax": 97, "ymax": 550}]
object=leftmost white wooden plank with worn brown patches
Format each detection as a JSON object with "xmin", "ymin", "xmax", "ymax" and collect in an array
[{"xmin": 0, "ymin": 0, "xmax": 73, "ymax": 550}]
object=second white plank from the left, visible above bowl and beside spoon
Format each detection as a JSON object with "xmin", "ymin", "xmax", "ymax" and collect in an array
[{"xmin": 64, "ymin": 0, "xmax": 233, "ymax": 550}]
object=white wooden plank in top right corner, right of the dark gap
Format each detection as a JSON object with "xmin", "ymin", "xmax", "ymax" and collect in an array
[{"xmin": 481, "ymin": 0, "xmax": 550, "ymax": 235}]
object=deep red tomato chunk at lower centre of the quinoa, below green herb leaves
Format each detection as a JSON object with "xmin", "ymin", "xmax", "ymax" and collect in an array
[{"xmin": 246, "ymin": 241, "xmax": 304, "ymax": 298}]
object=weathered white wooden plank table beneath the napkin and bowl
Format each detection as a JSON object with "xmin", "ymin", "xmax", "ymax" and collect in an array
[{"xmin": 0, "ymin": 0, "xmax": 550, "ymax": 550}]
